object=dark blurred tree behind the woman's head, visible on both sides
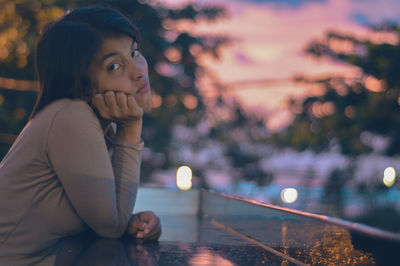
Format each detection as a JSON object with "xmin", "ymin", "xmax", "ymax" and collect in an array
[{"xmin": 0, "ymin": 0, "xmax": 228, "ymax": 179}]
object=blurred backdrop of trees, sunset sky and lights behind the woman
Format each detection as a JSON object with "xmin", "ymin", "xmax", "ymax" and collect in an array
[{"xmin": 0, "ymin": 0, "xmax": 400, "ymax": 232}]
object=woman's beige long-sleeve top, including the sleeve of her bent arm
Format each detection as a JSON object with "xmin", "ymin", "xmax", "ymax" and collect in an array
[{"xmin": 0, "ymin": 99, "xmax": 143, "ymax": 257}]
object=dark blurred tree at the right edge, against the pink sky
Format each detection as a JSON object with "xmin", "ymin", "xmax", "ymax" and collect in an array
[{"xmin": 272, "ymin": 24, "xmax": 400, "ymax": 155}]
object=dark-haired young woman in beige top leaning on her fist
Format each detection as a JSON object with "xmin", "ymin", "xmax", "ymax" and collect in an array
[{"xmin": 0, "ymin": 7, "xmax": 161, "ymax": 257}]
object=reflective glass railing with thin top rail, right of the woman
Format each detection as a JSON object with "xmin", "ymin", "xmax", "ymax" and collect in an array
[{"xmin": 135, "ymin": 188, "xmax": 400, "ymax": 265}]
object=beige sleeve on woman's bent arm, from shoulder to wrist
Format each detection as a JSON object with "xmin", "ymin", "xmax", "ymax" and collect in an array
[{"xmin": 47, "ymin": 101, "xmax": 143, "ymax": 237}]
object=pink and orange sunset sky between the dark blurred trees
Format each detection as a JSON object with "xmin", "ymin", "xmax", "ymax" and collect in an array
[{"xmin": 161, "ymin": 0, "xmax": 400, "ymax": 128}]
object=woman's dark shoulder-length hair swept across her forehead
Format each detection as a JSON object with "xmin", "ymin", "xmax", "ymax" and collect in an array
[{"xmin": 31, "ymin": 6, "xmax": 139, "ymax": 118}]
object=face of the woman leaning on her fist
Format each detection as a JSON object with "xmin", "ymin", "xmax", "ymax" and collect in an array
[{"xmin": 87, "ymin": 36, "xmax": 151, "ymax": 110}]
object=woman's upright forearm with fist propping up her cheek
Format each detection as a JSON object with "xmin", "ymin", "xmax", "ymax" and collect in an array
[{"xmin": 87, "ymin": 91, "xmax": 143, "ymax": 236}]
